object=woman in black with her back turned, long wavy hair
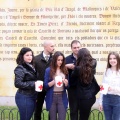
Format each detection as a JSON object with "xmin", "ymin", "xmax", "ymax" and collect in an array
[{"xmin": 71, "ymin": 48, "xmax": 99, "ymax": 120}]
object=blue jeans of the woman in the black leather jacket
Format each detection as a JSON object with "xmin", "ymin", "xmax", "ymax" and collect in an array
[{"xmin": 15, "ymin": 92, "xmax": 37, "ymax": 120}]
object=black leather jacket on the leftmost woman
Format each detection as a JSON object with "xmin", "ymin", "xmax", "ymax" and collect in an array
[{"xmin": 14, "ymin": 63, "xmax": 37, "ymax": 94}]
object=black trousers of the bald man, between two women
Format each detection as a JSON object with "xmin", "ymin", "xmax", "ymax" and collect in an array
[{"xmin": 34, "ymin": 91, "xmax": 46, "ymax": 120}]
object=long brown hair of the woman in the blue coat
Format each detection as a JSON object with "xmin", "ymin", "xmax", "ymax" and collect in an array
[{"xmin": 50, "ymin": 51, "xmax": 68, "ymax": 78}]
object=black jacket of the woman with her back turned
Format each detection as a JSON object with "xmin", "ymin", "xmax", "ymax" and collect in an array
[{"xmin": 71, "ymin": 59, "xmax": 100, "ymax": 99}]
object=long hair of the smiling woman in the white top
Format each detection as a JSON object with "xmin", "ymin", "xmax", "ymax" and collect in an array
[{"xmin": 107, "ymin": 52, "xmax": 120, "ymax": 71}]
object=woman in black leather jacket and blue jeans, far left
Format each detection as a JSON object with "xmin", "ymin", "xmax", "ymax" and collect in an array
[{"xmin": 14, "ymin": 47, "xmax": 37, "ymax": 120}]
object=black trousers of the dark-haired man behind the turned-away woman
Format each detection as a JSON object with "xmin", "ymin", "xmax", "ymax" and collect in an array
[{"xmin": 68, "ymin": 88, "xmax": 78, "ymax": 120}]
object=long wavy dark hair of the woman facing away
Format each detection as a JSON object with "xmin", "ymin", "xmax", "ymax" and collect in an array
[{"xmin": 76, "ymin": 48, "xmax": 93, "ymax": 84}]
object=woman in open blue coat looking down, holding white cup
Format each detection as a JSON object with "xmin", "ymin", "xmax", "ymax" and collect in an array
[{"xmin": 44, "ymin": 51, "xmax": 68, "ymax": 120}]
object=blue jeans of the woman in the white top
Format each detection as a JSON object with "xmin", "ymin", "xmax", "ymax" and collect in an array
[{"xmin": 103, "ymin": 94, "xmax": 120, "ymax": 120}]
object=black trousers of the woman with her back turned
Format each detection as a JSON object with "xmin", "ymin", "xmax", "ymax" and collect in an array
[{"xmin": 78, "ymin": 97, "xmax": 96, "ymax": 120}]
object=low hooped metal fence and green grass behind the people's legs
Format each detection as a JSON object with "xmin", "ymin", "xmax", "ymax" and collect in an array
[{"xmin": 0, "ymin": 108, "xmax": 104, "ymax": 120}]
